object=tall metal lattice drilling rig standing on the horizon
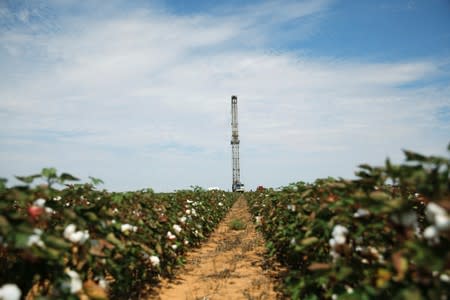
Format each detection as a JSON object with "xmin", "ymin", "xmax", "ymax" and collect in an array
[{"xmin": 231, "ymin": 96, "xmax": 244, "ymax": 192}]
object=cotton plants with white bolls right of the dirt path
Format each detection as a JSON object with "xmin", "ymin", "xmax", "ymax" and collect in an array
[{"xmin": 247, "ymin": 149, "xmax": 450, "ymax": 300}]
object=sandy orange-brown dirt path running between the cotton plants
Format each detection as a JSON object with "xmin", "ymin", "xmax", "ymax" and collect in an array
[{"xmin": 150, "ymin": 197, "xmax": 277, "ymax": 300}]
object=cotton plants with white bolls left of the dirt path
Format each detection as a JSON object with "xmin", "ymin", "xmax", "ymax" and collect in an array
[{"xmin": 0, "ymin": 169, "xmax": 234, "ymax": 300}]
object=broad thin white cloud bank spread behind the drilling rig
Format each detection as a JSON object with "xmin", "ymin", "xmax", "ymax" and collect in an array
[{"xmin": 0, "ymin": 1, "xmax": 450, "ymax": 191}]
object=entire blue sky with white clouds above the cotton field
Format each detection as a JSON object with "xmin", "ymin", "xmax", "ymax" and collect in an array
[{"xmin": 0, "ymin": 0, "xmax": 450, "ymax": 192}]
